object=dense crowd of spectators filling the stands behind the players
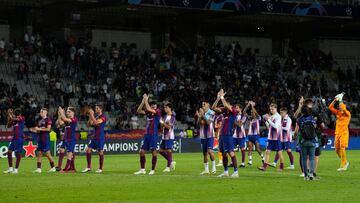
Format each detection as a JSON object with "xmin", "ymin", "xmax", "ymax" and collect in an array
[{"xmin": 0, "ymin": 33, "xmax": 360, "ymax": 128}]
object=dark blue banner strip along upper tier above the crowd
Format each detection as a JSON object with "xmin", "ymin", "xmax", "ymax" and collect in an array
[{"xmin": 127, "ymin": 0, "xmax": 360, "ymax": 17}]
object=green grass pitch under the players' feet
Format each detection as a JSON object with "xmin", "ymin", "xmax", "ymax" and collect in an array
[{"xmin": 0, "ymin": 151, "xmax": 360, "ymax": 203}]
